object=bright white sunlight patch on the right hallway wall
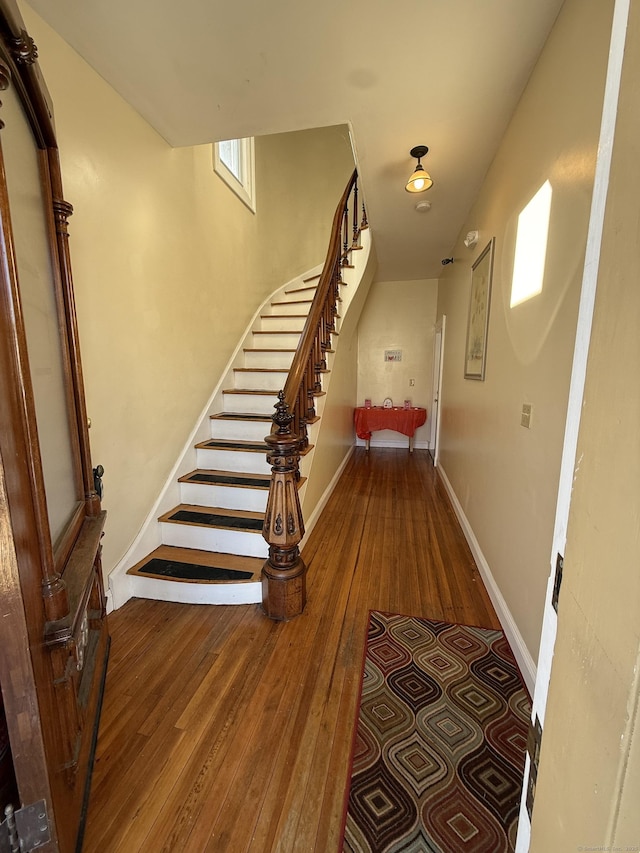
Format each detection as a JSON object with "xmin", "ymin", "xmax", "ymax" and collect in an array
[{"xmin": 510, "ymin": 181, "xmax": 553, "ymax": 308}]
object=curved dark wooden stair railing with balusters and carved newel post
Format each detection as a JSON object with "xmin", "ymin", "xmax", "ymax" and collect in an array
[{"xmin": 262, "ymin": 170, "xmax": 368, "ymax": 621}]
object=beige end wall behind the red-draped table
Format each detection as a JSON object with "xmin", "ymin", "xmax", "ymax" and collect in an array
[{"xmin": 357, "ymin": 279, "xmax": 438, "ymax": 445}]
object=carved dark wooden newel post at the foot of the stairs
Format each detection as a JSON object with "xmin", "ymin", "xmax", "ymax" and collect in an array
[{"xmin": 262, "ymin": 391, "xmax": 307, "ymax": 621}]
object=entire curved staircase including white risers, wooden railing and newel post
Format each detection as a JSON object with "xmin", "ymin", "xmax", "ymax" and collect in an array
[{"xmin": 109, "ymin": 171, "xmax": 375, "ymax": 620}]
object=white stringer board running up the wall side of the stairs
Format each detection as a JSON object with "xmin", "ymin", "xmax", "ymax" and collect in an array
[{"xmin": 107, "ymin": 264, "xmax": 322, "ymax": 610}]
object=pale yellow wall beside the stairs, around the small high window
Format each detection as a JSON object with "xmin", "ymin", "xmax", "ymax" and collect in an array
[{"xmin": 22, "ymin": 5, "xmax": 353, "ymax": 572}]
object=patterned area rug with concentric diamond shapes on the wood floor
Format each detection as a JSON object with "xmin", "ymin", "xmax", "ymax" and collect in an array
[{"xmin": 342, "ymin": 611, "xmax": 530, "ymax": 853}]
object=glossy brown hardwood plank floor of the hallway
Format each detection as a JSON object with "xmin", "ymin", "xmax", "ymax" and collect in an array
[{"xmin": 83, "ymin": 448, "xmax": 500, "ymax": 853}]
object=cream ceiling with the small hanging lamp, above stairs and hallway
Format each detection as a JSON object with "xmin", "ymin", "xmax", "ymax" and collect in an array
[{"xmin": 30, "ymin": 0, "xmax": 562, "ymax": 280}]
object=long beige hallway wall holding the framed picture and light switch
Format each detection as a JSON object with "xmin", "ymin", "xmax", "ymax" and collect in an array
[{"xmin": 438, "ymin": 0, "xmax": 613, "ymax": 661}]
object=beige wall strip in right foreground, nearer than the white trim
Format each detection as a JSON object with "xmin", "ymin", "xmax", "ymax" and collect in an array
[{"xmin": 530, "ymin": 0, "xmax": 640, "ymax": 853}]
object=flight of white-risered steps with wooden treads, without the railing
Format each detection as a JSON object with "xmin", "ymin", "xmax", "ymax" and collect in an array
[{"xmin": 127, "ymin": 275, "xmax": 328, "ymax": 604}]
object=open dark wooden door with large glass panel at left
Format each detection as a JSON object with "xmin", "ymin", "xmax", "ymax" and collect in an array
[{"xmin": 0, "ymin": 0, "xmax": 108, "ymax": 853}]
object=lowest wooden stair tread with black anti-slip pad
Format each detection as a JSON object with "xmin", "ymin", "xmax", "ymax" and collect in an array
[{"xmin": 127, "ymin": 545, "xmax": 264, "ymax": 583}]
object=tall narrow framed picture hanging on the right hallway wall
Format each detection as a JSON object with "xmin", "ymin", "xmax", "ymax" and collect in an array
[{"xmin": 464, "ymin": 237, "xmax": 495, "ymax": 382}]
